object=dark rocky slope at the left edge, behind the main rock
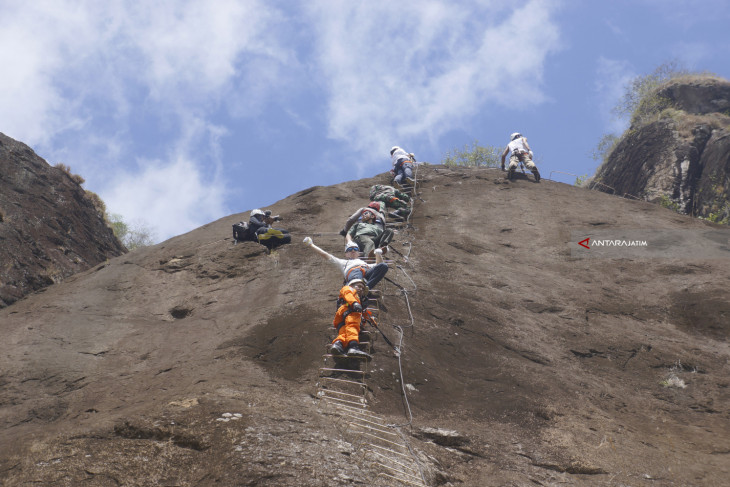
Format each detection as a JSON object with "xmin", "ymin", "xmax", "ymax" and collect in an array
[{"xmin": 0, "ymin": 133, "xmax": 125, "ymax": 308}]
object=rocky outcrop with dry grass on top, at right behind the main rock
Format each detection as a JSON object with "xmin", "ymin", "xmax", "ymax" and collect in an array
[{"xmin": 591, "ymin": 76, "xmax": 730, "ymax": 221}]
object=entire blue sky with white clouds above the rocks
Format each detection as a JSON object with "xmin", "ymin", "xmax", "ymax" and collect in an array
[{"xmin": 0, "ymin": 0, "xmax": 730, "ymax": 241}]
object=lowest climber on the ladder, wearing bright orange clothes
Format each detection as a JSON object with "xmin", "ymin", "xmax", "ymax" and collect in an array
[{"xmin": 330, "ymin": 279, "xmax": 368, "ymax": 357}]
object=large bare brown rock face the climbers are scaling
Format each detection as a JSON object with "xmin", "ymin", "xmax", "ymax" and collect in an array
[{"xmin": 0, "ymin": 166, "xmax": 730, "ymax": 487}]
